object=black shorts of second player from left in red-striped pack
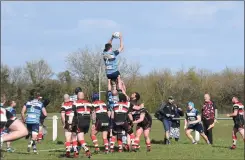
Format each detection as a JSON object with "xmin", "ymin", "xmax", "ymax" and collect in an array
[{"xmin": 77, "ymin": 115, "xmax": 90, "ymax": 134}]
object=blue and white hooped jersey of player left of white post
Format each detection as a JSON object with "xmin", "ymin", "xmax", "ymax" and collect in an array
[{"xmin": 25, "ymin": 99, "xmax": 43, "ymax": 124}]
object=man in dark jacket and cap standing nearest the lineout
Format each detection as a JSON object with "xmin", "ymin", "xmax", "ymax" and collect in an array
[{"xmin": 159, "ymin": 96, "xmax": 176, "ymax": 144}]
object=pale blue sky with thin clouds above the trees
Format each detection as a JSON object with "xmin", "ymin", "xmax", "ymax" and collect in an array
[{"xmin": 1, "ymin": 1, "xmax": 244, "ymax": 74}]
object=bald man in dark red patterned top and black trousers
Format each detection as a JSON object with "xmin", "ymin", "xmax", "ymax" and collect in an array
[{"xmin": 202, "ymin": 93, "xmax": 216, "ymax": 144}]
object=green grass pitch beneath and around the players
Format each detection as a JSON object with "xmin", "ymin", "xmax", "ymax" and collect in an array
[{"xmin": 1, "ymin": 114, "xmax": 244, "ymax": 160}]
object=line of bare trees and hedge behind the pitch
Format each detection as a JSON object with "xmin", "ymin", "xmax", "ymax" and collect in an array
[{"xmin": 1, "ymin": 48, "xmax": 244, "ymax": 112}]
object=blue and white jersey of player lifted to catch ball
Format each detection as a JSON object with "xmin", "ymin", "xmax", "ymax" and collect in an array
[{"xmin": 102, "ymin": 50, "xmax": 119, "ymax": 74}]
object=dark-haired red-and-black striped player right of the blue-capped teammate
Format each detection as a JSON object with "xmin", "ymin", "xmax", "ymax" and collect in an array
[{"xmin": 110, "ymin": 94, "xmax": 136, "ymax": 152}]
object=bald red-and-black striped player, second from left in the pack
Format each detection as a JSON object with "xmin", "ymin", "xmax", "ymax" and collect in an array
[{"xmin": 72, "ymin": 92, "xmax": 92, "ymax": 158}]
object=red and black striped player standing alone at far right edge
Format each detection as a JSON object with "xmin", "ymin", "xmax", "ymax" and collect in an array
[{"xmin": 227, "ymin": 96, "xmax": 245, "ymax": 149}]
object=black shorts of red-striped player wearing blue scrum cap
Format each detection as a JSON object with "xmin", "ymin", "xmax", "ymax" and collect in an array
[{"xmin": 95, "ymin": 114, "xmax": 109, "ymax": 132}]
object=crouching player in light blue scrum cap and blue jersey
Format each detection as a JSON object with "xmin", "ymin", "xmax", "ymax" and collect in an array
[{"xmin": 184, "ymin": 102, "xmax": 210, "ymax": 144}]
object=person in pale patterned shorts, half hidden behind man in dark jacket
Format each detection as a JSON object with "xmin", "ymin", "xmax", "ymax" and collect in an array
[{"xmin": 170, "ymin": 105, "xmax": 184, "ymax": 141}]
